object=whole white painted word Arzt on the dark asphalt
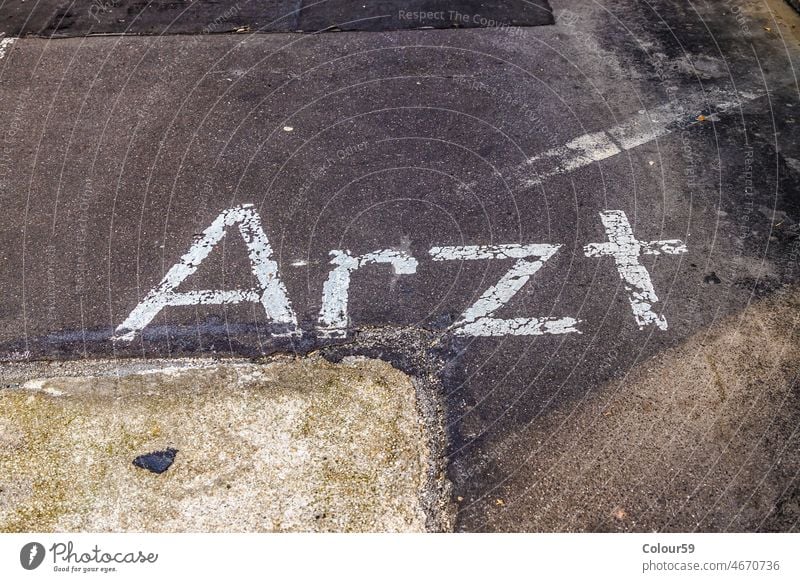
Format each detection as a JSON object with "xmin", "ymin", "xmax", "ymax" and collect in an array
[{"xmin": 112, "ymin": 204, "xmax": 686, "ymax": 341}]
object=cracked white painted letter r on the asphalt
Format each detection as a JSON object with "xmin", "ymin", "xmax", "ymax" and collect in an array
[{"xmin": 317, "ymin": 249, "xmax": 418, "ymax": 338}]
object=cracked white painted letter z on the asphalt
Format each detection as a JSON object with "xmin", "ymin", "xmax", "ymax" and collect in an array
[{"xmin": 428, "ymin": 244, "xmax": 580, "ymax": 337}]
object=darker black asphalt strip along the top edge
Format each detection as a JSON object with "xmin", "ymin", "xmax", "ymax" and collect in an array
[{"xmin": 0, "ymin": 0, "xmax": 553, "ymax": 37}]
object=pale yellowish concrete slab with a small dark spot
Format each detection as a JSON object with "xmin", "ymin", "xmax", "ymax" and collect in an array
[{"xmin": 0, "ymin": 357, "xmax": 452, "ymax": 532}]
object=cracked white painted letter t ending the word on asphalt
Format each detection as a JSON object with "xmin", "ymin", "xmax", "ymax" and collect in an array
[{"xmin": 583, "ymin": 210, "xmax": 688, "ymax": 330}]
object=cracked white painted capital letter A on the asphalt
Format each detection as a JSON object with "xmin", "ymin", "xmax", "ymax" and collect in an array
[{"xmin": 112, "ymin": 204, "xmax": 297, "ymax": 341}]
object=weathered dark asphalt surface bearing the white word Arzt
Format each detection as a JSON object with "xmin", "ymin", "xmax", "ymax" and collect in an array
[{"xmin": 0, "ymin": 0, "xmax": 800, "ymax": 531}]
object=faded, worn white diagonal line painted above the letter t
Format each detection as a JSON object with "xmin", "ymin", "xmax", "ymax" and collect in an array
[{"xmin": 518, "ymin": 92, "xmax": 762, "ymax": 186}]
